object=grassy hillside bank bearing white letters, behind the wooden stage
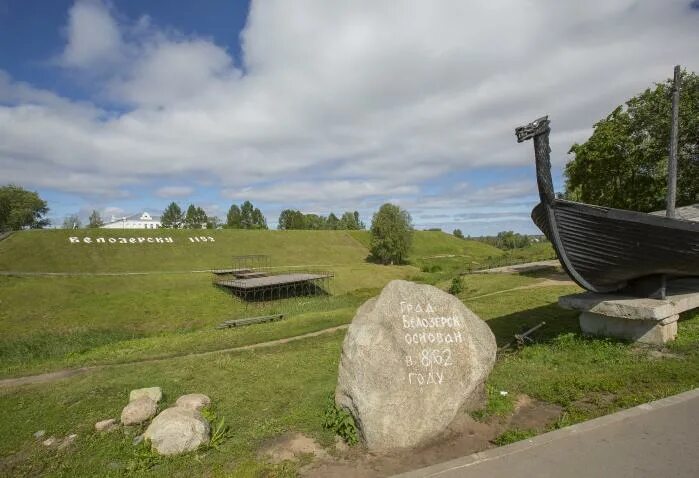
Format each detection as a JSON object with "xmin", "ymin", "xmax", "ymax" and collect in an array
[{"xmin": 0, "ymin": 229, "xmax": 367, "ymax": 272}]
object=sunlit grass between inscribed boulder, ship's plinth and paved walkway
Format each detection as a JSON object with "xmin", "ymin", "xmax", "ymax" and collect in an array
[{"xmin": 482, "ymin": 312, "xmax": 699, "ymax": 427}]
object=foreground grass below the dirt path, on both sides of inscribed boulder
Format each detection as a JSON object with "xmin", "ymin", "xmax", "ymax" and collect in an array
[{"xmin": 0, "ymin": 287, "xmax": 699, "ymax": 476}]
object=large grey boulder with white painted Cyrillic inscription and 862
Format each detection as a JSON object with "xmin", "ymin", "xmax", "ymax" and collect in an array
[{"xmin": 335, "ymin": 280, "xmax": 497, "ymax": 450}]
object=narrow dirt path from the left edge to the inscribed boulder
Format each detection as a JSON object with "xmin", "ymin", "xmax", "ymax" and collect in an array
[{"xmin": 0, "ymin": 324, "xmax": 349, "ymax": 388}]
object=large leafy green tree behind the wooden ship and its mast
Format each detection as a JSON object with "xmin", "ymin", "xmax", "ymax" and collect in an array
[{"xmin": 564, "ymin": 71, "xmax": 699, "ymax": 212}]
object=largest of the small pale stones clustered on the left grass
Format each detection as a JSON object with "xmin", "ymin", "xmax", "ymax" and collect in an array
[{"xmin": 143, "ymin": 407, "xmax": 210, "ymax": 455}]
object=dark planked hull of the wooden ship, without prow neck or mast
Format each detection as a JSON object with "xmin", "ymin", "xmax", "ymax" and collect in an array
[{"xmin": 532, "ymin": 199, "xmax": 699, "ymax": 292}]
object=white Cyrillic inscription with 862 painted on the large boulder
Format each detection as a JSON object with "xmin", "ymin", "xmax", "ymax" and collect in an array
[{"xmin": 400, "ymin": 301, "xmax": 464, "ymax": 387}]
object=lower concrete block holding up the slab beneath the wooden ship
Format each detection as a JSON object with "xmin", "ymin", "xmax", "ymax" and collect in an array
[{"xmin": 580, "ymin": 312, "xmax": 679, "ymax": 345}]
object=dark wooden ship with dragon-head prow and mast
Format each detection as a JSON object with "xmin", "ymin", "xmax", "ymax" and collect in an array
[{"xmin": 515, "ymin": 73, "xmax": 699, "ymax": 298}]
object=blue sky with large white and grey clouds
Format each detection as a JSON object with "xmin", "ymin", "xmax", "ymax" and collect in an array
[{"xmin": 0, "ymin": 0, "xmax": 699, "ymax": 236}]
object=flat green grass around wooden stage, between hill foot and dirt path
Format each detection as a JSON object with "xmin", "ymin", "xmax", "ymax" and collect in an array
[{"xmin": 0, "ymin": 263, "xmax": 415, "ymax": 377}]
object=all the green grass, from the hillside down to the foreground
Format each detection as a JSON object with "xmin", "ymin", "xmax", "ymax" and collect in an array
[{"xmin": 0, "ymin": 231, "xmax": 699, "ymax": 477}]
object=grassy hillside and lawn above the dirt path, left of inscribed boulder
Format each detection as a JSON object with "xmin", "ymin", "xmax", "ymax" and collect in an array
[{"xmin": 0, "ymin": 230, "xmax": 417, "ymax": 376}]
